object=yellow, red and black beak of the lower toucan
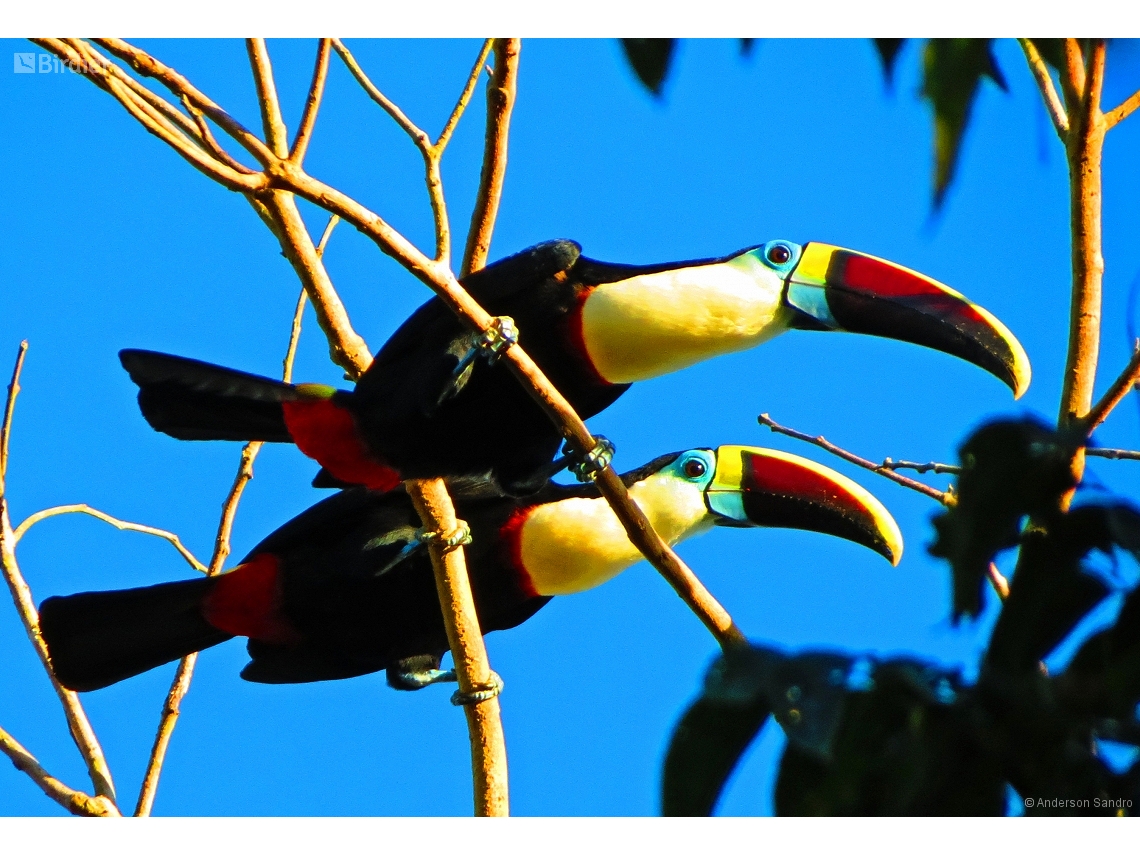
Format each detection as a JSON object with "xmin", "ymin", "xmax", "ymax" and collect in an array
[{"xmin": 705, "ymin": 446, "xmax": 903, "ymax": 564}]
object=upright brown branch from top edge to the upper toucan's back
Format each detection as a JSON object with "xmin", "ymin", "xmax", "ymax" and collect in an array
[{"xmin": 461, "ymin": 39, "xmax": 521, "ymax": 276}]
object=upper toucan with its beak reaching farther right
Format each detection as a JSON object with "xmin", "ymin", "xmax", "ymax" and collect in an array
[{"xmin": 120, "ymin": 241, "xmax": 1029, "ymax": 495}]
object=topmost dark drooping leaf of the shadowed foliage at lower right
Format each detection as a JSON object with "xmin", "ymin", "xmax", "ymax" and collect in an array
[{"xmin": 930, "ymin": 418, "xmax": 1074, "ymax": 624}]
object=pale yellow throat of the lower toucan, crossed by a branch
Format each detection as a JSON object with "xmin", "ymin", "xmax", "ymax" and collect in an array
[{"xmin": 512, "ymin": 477, "xmax": 713, "ymax": 596}]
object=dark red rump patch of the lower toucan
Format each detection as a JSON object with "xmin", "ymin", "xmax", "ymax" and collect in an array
[{"xmin": 202, "ymin": 553, "xmax": 300, "ymax": 644}]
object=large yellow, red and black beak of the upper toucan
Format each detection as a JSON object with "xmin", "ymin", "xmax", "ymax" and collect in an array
[{"xmin": 784, "ymin": 243, "xmax": 1031, "ymax": 398}]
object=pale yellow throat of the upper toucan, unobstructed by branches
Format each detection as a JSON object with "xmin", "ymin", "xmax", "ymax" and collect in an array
[{"xmin": 580, "ymin": 257, "xmax": 791, "ymax": 383}]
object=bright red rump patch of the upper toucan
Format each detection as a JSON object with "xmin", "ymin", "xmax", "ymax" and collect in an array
[{"xmin": 282, "ymin": 398, "xmax": 401, "ymax": 492}]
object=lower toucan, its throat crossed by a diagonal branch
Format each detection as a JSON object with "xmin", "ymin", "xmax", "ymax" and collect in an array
[{"xmin": 40, "ymin": 446, "xmax": 903, "ymax": 692}]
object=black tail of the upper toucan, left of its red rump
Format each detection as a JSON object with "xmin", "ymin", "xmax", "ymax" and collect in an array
[{"xmin": 119, "ymin": 350, "xmax": 299, "ymax": 442}]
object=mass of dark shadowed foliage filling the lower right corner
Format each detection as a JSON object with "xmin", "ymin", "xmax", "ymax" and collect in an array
[{"xmin": 662, "ymin": 420, "xmax": 1140, "ymax": 815}]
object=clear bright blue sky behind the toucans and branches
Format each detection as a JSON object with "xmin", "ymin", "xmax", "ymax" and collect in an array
[{"xmin": 0, "ymin": 40, "xmax": 1140, "ymax": 815}]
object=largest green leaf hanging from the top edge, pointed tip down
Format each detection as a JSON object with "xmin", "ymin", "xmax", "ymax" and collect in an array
[{"xmin": 922, "ymin": 39, "xmax": 1007, "ymax": 209}]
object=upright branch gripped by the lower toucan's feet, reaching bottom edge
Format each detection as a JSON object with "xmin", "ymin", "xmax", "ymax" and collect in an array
[{"xmin": 405, "ymin": 478, "xmax": 510, "ymax": 816}]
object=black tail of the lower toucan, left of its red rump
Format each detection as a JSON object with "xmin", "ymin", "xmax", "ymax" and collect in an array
[{"xmin": 40, "ymin": 577, "xmax": 233, "ymax": 692}]
